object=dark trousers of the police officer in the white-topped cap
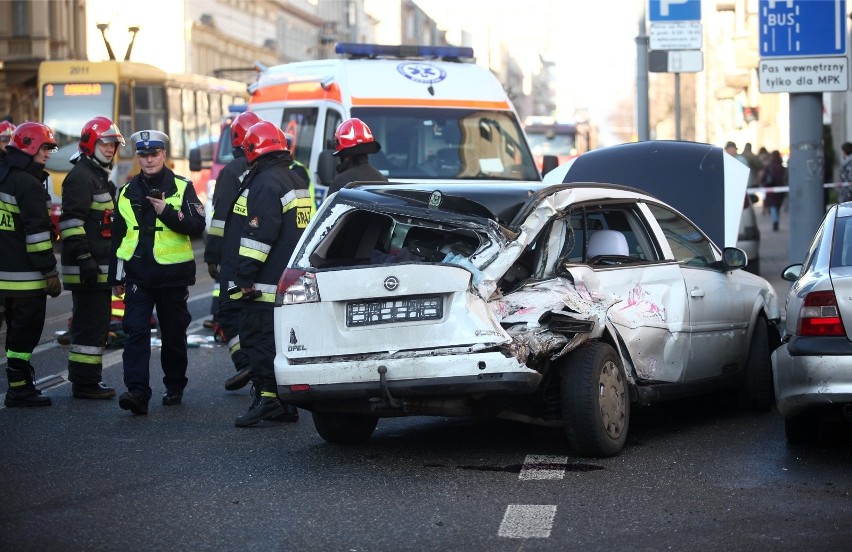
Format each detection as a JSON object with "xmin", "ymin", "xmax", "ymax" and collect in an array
[{"xmin": 122, "ymin": 284, "xmax": 192, "ymax": 402}]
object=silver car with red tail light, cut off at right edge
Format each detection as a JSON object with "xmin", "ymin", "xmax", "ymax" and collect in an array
[{"xmin": 772, "ymin": 203, "xmax": 852, "ymax": 443}]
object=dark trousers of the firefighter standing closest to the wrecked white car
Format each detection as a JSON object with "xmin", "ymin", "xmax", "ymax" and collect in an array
[{"xmin": 240, "ymin": 305, "xmax": 277, "ymax": 392}]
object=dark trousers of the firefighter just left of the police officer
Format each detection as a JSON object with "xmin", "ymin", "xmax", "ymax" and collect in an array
[{"xmin": 68, "ymin": 289, "xmax": 112, "ymax": 385}]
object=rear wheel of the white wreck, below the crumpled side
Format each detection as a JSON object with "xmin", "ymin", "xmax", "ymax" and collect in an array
[{"xmin": 560, "ymin": 341, "xmax": 630, "ymax": 457}]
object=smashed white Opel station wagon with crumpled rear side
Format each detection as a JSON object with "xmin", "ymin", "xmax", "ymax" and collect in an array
[{"xmin": 275, "ymin": 143, "xmax": 779, "ymax": 456}]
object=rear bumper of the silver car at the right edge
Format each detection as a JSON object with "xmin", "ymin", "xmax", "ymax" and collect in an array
[{"xmin": 772, "ymin": 338, "xmax": 852, "ymax": 418}]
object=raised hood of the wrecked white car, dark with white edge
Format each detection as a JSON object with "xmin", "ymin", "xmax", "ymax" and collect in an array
[{"xmin": 544, "ymin": 140, "xmax": 749, "ymax": 247}]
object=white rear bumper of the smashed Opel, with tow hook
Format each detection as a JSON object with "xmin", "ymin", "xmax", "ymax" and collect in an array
[{"xmin": 275, "ymin": 353, "xmax": 542, "ymax": 404}]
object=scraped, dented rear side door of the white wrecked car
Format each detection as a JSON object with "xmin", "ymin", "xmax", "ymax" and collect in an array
[{"xmin": 560, "ymin": 203, "xmax": 689, "ymax": 382}]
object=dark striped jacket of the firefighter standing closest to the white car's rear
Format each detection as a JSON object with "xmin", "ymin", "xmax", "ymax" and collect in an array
[{"xmin": 234, "ymin": 151, "xmax": 315, "ymax": 309}]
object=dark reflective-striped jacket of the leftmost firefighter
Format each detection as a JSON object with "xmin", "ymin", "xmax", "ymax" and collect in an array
[{"xmin": 0, "ymin": 144, "xmax": 56, "ymax": 297}]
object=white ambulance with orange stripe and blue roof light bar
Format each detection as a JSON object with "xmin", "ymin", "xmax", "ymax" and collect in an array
[{"xmin": 249, "ymin": 43, "xmax": 541, "ymax": 203}]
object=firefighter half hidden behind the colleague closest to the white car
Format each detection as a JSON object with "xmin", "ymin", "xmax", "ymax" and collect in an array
[{"xmin": 204, "ymin": 111, "xmax": 261, "ymax": 391}]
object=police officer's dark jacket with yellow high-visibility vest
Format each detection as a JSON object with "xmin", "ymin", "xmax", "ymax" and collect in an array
[{"xmin": 109, "ymin": 168, "xmax": 205, "ymax": 288}]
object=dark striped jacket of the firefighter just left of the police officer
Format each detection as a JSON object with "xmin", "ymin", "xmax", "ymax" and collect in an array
[{"xmin": 59, "ymin": 155, "xmax": 115, "ymax": 290}]
